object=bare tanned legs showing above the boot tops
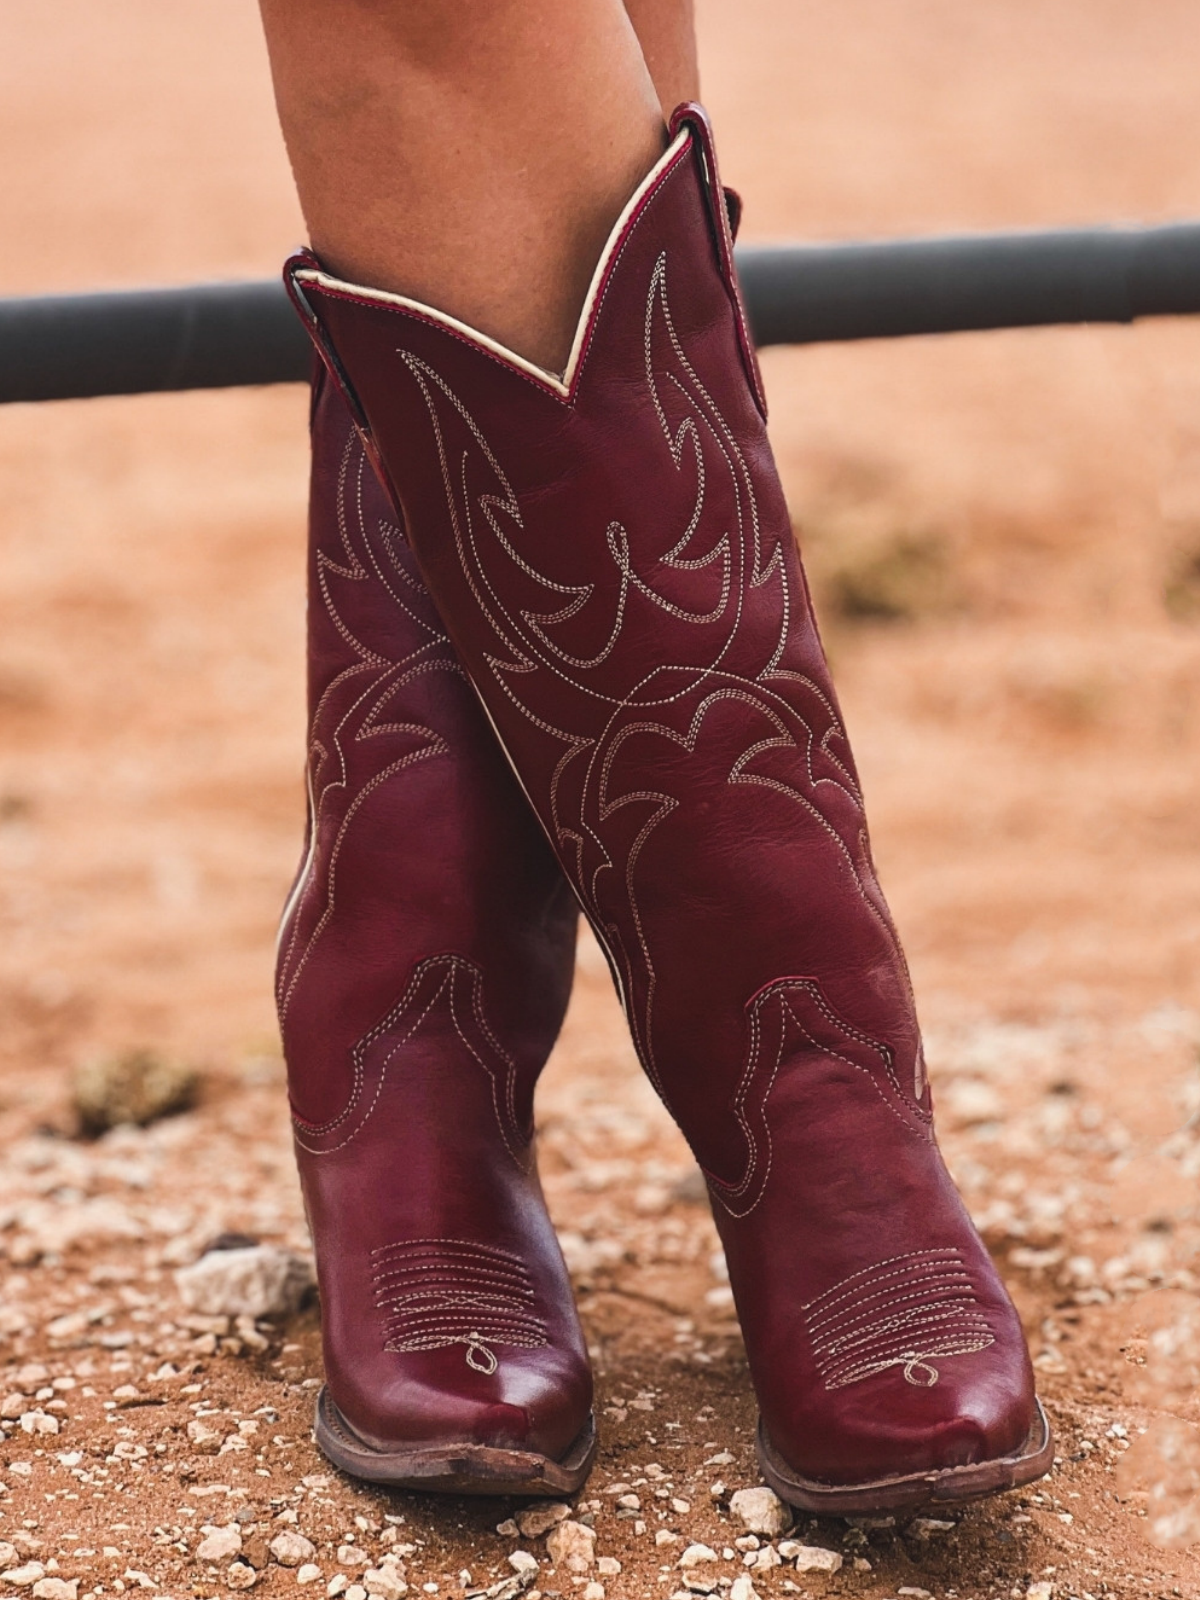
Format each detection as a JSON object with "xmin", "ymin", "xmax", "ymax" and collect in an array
[{"xmin": 261, "ymin": 0, "xmax": 698, "ymax": 371}]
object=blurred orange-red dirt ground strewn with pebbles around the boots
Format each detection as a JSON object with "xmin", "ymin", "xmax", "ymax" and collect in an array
[{"xmin": 0, "ymin": 0, "xmax": 1200, "ymax": 1600}]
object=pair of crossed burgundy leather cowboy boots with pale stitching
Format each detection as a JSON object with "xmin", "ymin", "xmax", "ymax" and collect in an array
[{"xmin": 278, "ymin": 106, "xmax": 1051, "ymax": 1514}]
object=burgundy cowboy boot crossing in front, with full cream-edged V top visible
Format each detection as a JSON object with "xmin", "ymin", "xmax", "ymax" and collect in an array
[{"xmin": 288, "ymin": 107, "xmax": 1051, "ymax": 1512}]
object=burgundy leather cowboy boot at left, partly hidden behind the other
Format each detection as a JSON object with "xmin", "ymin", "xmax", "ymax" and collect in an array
[{"xmin": 277, "ymin": 374, "xmax": 595, "ymax": 1494}]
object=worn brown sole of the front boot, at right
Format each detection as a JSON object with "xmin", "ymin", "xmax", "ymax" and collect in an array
[{"xmin": 757, "ymin": 1400, "xmax": 1054, "ymax": 1517}]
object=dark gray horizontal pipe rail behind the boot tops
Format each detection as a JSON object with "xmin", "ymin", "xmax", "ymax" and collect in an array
[{"xmin": 0, "ymin": 222, "xmax": 1200, "ymax": 402}]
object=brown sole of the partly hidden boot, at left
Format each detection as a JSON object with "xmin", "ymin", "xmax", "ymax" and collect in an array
[{"xmin": 312, "ymin": 1389, "xmax": 597, "ymax": 1498}]
